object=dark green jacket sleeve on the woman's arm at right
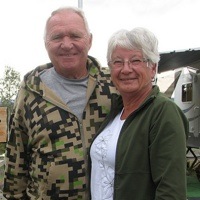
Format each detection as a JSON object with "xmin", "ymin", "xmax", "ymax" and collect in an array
[{"xmin": 149, "ymin": 101, "xmax": 189, "ymax": 200}]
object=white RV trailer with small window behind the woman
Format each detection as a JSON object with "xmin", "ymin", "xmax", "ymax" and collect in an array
[{"xmin": 174, "ymin": 67, "xmax": 200, "ymax": 167}]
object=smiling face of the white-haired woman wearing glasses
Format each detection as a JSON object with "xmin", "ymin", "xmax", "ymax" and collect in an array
[{"xmin": 109, "ymin": 47, "xmax": 156, "ymax": 96}]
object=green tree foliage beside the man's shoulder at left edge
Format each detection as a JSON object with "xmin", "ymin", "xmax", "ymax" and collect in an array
[{"xmin": 0, "ymin": 66, "xmax": 20, "ymax": 113}]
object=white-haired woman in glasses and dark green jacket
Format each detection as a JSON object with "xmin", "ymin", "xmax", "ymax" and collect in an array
[{"xmin": 90, "ymin": 28, "xmax": 188, "ymax": 200}]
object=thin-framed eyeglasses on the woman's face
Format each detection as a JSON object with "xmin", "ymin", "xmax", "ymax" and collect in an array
[{"xmin": 108, "ymin": 58, "xmax": 149, "ymax": 69}]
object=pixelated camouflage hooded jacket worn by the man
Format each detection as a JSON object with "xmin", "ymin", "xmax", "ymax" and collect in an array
[{"xmin": 3, "ymin": 57, "xmax": 117, "ymax": 200}]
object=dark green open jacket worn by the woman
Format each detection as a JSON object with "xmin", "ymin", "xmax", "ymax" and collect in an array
[{"xmin": 89, "ymin": 86, "xmax": 188, "ymax": 200}]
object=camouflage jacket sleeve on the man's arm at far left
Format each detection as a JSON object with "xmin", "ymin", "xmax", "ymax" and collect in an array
[{"xmin": 3, "ymin": 88, "xmax": 29, "ymax": 199}]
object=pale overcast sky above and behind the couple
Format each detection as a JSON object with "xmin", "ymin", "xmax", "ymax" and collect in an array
[{"xmin": 0, "ymin": 0, "xmax": 200, "ymax": 76}]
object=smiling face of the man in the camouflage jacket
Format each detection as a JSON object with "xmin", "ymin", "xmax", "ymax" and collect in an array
[{"xmin": 45, "ymin": 11, "xmax": 92, "ymax": 78}]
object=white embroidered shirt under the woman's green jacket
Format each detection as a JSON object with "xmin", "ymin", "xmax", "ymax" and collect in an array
[{"xmin": 90, "ymin": 111, "xmax": 125, "ymax": 200}]
